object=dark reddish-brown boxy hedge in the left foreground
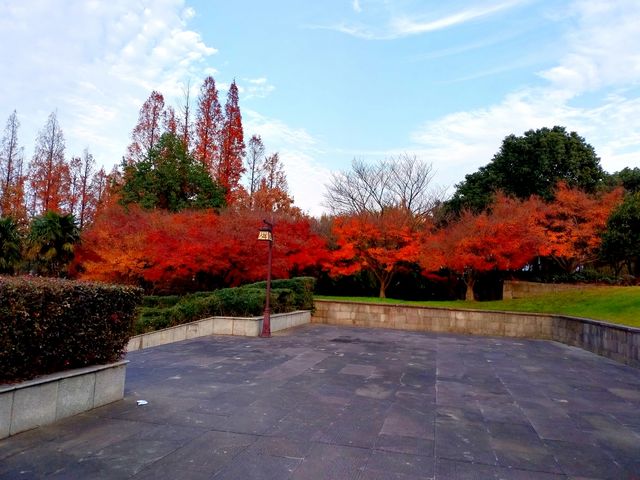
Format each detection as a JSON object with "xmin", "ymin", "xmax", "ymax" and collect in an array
[{"xmin": 0, "ymin": 277, "xmax": 142, "ymax": 383}]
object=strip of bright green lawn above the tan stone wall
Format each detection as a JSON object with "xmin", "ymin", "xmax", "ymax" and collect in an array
[{"xmin": 316, "ymin": 286, "xmax": 640, "ymax": 327}]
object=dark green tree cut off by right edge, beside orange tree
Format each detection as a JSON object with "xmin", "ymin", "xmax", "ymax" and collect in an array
[{"xmin": 600, "ymin": 191, "xmax": 640, "ymax": 276}]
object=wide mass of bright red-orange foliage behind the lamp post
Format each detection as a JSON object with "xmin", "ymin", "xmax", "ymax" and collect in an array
[{"xmin": 75, "ymin": 204, "xmax": 324, "ymax": 292}]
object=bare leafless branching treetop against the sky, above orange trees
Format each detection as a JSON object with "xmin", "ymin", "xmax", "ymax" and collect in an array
[{"xmin": 325, "ymin": 154, "xmax": 441, "ymax": 216}]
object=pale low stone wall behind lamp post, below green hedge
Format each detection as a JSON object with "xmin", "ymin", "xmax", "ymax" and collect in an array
[{"xmin": 127, "ymin": 310, "xmax": 311, "ymax": 352}]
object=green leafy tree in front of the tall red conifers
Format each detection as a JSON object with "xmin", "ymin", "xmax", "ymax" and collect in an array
[{"xmin": 120, "ymin": 133, "xmax": 225, "ymax": 212}]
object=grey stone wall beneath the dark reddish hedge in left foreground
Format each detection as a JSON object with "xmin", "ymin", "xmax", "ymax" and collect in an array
[{"xmin": 0, "ymin": 360, "xmax": 128, "ymax": 438}]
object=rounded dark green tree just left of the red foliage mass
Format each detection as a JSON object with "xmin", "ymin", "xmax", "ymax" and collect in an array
[{"xmin": 27, "ymin": 211, "xmax": 80, "ymax": 276}]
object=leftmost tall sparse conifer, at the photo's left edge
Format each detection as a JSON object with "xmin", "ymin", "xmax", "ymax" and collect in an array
[{"xmin": 0, "ymin": 110, "xmax": 27, "ymax": 221}]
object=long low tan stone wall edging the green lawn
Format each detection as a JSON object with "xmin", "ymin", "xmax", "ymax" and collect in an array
[{"xmin": 311, "ymin": 300, "xmax": 640, "ymax": 367}]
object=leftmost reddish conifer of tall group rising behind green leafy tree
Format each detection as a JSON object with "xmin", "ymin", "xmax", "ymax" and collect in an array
[{"xmin": 126, "ymin": 90, "xmax": 165, "ymax": 163}]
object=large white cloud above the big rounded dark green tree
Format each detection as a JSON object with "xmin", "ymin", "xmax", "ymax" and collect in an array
[{"xmin": 411, "ymin": 1, "xmax": 640, "ymax": 189}]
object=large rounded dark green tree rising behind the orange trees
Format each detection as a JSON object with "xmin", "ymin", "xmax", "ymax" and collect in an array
[{"xmin": 447, "ymin": 126, "xmax": 605, "ymax": 213}]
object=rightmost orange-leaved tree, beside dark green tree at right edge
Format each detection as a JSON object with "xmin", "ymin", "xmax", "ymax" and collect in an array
[{"xmin": 537, "ymin": 182, "xmax": 624, "ymax": 273}]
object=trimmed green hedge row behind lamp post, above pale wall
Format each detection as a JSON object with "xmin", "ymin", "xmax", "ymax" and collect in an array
[{"xmin": 139, "ymin": 277, "xmax": 315, "ymax": 334}]
